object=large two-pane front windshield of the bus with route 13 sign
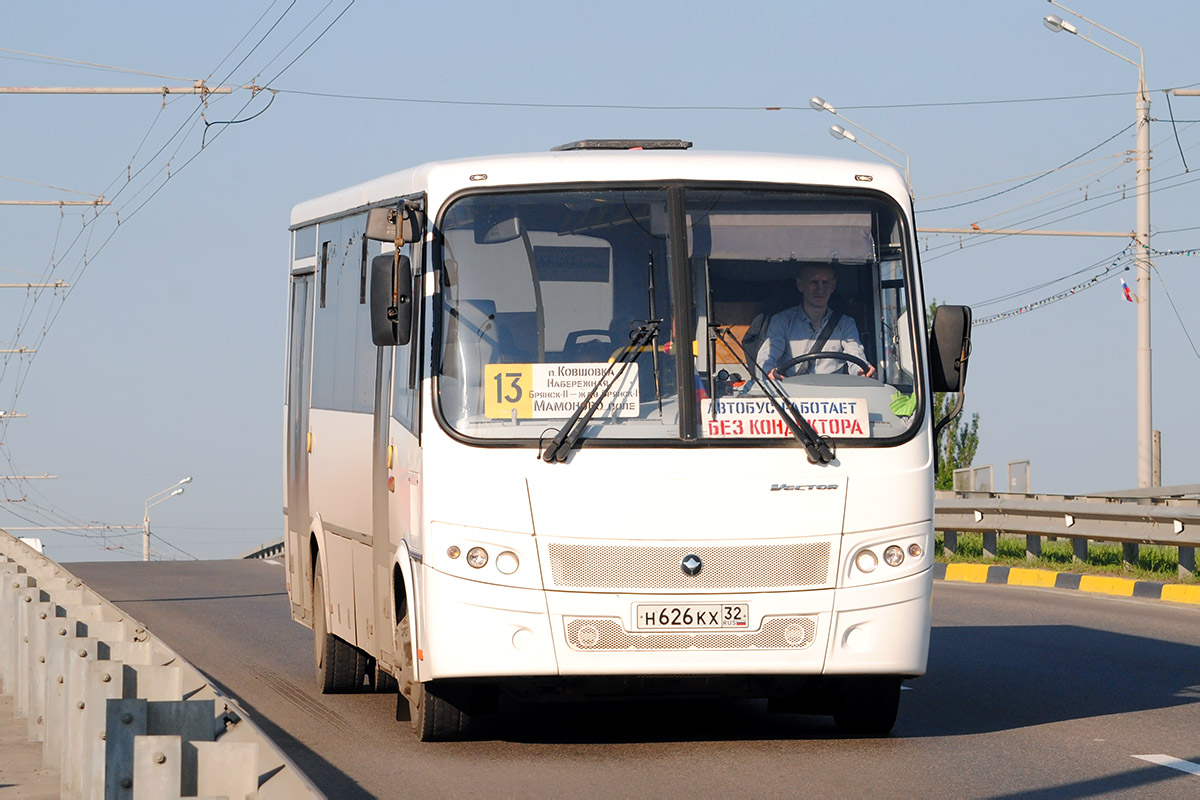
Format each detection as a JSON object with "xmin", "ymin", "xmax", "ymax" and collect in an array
[{"xmin": 437, "ymin": 185, "xmax": 923, "ymax": 445}]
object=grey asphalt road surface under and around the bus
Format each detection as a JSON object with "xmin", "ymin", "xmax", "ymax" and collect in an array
[{"xmin": 66, "ymin": 561, "xmax": 1200, "ymax": 798}]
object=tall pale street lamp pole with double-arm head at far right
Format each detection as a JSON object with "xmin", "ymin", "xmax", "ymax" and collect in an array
[{"xmin": 1042, "ymin": 0, "xmax": 1154, "ymax": 488}]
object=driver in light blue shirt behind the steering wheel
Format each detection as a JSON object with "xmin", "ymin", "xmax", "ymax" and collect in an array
[{"xmin": 757, "ymin": 264, "xmax": 875, "ymax": 380}]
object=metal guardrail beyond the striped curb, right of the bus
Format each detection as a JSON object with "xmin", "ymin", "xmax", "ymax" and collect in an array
[{"xmin": 934, "ymin": 487, "xmax": 1200, "ymax": 577}]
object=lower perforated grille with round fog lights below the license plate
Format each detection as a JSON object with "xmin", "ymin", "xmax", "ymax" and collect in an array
[{"xmin": 565, "ymin": 616, "xmax": 817, "ymax": 650}]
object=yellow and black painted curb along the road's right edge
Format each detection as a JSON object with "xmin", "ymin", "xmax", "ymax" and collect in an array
[{"xmin": 934, "ymin": 563, "xmax": 1200, "ymax": 606}]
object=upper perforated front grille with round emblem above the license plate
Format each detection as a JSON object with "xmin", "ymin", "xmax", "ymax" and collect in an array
[{"xmin": 548, "ymin": 540, "xmax": 833, "ymax": 590}]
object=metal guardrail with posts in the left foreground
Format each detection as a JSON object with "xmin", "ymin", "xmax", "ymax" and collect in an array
[{"xmin": 0, "ymin": 531, "xmax": 324, "ymax": 800}]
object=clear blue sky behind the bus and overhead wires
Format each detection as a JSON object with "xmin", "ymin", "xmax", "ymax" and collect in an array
[{"xmin": 0, "ymin": 0, "xmax": 1200, "ymax": 561}]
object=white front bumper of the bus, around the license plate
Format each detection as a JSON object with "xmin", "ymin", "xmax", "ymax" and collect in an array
[{"xmin": 418, "ymin": 567, "xmax": 932, "ymax": 680}]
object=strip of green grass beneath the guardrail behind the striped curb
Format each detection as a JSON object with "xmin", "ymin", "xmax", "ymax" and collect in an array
[{"xmin": 934, "ymin": 533, "xmax": 1200, "ymax": 584}]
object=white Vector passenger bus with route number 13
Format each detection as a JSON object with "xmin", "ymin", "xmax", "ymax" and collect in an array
[{"xmin": 284, "ymin": 140, "xmax": 970, "ymax": 740}]
